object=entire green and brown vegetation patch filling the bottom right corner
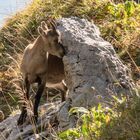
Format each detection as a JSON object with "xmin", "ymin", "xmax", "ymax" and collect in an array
[{"xmin": 59, "ymin": 96, "xmax": 140, "ymax": 140}]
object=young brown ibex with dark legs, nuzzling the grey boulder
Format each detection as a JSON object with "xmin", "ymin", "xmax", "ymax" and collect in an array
[{"xmin": 18, "ymin": 21, "xmax": 67, "ymax": 125}]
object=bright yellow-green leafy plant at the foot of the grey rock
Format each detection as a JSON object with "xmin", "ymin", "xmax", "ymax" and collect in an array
[{"xmin": 59, "ymin": 105, "xmax": 115, "ymax": 140}]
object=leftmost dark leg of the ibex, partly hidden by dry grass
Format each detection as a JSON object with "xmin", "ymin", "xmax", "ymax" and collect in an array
[{"xmin": 17, "ymin": 77, "xmax": 30, "ymax": 125}]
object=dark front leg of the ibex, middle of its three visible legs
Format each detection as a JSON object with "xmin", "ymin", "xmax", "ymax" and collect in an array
[{"xmin": 33, "ymin": 78, "xmax": 46, "ymax": 122}]
